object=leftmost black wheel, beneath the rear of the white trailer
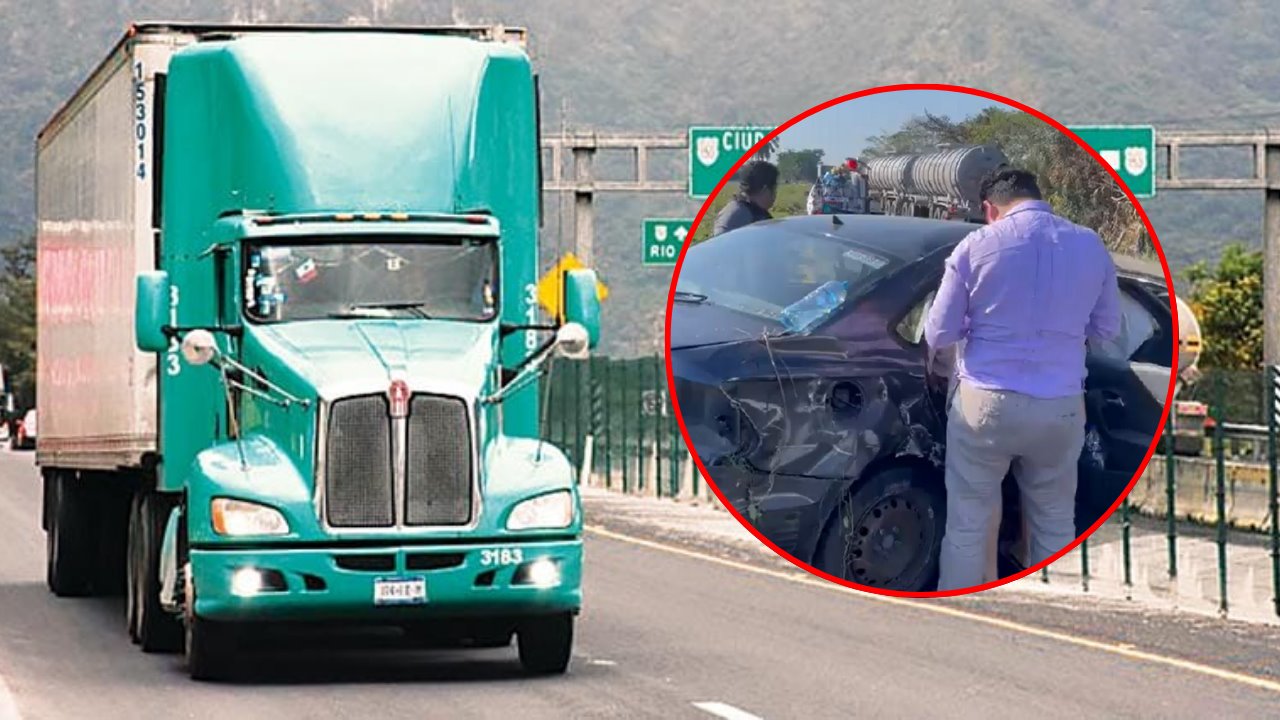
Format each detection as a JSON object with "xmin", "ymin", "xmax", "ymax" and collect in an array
[{"xmin": 45, "ymin": 470, "xmax": 96, "ymax": 597}]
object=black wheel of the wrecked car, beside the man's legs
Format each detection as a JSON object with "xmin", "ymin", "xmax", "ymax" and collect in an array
[{"xmin": 814, "ymin": 465, "xmax": 947, "ymax": 592}]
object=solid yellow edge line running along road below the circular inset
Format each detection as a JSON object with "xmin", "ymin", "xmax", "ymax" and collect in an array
[{"xmin": 586, "ymin": 525, "xmax": 1280, "ymax": 693}]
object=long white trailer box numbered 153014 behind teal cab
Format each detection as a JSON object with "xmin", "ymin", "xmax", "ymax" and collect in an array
[{"xmin": 36, "ymin": 27, "xmax": 195, "ymax": 469}]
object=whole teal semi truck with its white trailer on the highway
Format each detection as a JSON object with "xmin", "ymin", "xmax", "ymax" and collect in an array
[{"xmin": 36, "ymin": 23, "xmax": 599, "ymax": 678}]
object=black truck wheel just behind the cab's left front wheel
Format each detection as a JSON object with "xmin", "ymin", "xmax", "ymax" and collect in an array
[{"xmin": 125, "ymin": 491, "xmax": 182, "ymax": 652}]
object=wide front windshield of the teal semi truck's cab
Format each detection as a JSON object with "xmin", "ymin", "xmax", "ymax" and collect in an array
[{"xmin": 243, "ymin": 237, "xmax": 498, "ymax": 323}]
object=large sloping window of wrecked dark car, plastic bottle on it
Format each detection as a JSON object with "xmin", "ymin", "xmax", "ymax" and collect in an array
[{"xmin": 676, "ymin": 228, "xmax": 893, "ymax": 328}]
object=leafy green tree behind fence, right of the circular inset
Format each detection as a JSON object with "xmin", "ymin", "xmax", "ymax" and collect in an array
[{"xmin": 1185, "ymin": 242, "xmax": 1262, "ymax": 370}]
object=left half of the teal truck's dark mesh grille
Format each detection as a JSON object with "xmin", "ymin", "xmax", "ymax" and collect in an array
[{"xmin": 325, "ymin": 395, "xmax": 396, "ymax": 528}]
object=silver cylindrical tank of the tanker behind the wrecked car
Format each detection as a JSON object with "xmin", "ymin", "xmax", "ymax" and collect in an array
[{"xmin": 867, "ymin": 145, "xmax": 1009, "ymax": 223}]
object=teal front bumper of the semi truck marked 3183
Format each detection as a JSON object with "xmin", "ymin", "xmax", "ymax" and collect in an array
[{"xmin": 191, "ymin": 538, "xmax": 582, "ymax": 623}]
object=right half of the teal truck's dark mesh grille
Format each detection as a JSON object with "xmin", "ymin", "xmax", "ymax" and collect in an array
[{"xmin": 404, "ymin": 395, "xmax": 471, "ymax": 525}]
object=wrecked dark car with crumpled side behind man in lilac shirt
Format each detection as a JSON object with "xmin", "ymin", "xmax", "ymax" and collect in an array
[{"xmin": 668, "ymin": 215, "xmax": 1175, "ymax": 592}]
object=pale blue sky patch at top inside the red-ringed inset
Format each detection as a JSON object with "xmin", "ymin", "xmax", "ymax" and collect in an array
[{"xmin": 778, "ymin": 90, "xmax": 1009, "ymax": 163}]
